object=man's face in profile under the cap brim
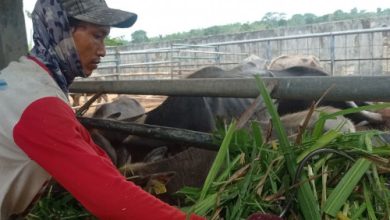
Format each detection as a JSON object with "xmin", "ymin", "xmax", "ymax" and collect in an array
[{"xmin": 72, "ymin": 22, "xmax": 110, "ymax": 76}]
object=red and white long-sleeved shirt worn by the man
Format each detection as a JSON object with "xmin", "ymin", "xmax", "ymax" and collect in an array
[{"xmin": 0, "ymin": 57, "xmax": 203, "ymax": 220}]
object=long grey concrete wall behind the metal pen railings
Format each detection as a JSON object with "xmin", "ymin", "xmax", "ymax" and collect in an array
[{"xmin": 98, "ymin": 17, "xmax": 390, "ymax": 75}]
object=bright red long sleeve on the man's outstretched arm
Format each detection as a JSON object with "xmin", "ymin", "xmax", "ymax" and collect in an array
[{"xmin": 13, "ymin": 97, "xmax": 204, "ymax": 220}]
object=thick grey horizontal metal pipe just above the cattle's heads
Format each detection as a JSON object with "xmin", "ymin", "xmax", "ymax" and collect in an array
[{"xmin": 70, "ymin": 76, "xmax": 390, "ymax": 101}]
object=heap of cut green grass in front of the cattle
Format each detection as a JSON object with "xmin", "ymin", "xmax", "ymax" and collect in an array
[{"xmin": 180, "ymin": 76, "xmax": 390, "ymax": 220}]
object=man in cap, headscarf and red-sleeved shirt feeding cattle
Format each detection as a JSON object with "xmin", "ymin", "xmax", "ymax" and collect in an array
[{"xmin": 0, "ymin": 0, "xmax": 203, "ymax": 220}]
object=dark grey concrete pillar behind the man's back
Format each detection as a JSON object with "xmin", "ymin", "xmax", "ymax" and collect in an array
[{"xmin": 0, "ymin": 0, "xmax": 28, "ymax": 69}]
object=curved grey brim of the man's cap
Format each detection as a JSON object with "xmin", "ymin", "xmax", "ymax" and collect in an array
[{"xmin": 74, "ymin": 8, "xmax": 137, "ymax": 28}]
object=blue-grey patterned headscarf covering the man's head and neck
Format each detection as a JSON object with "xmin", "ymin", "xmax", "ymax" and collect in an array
[{"xmin": 30, "ymin": 0, "xmax": 86, "ymax": 94}]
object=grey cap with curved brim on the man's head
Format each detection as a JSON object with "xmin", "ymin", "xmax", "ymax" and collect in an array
[{"xmin": 60, "ymin": 0, "xmax": 137, "ymax": 28}]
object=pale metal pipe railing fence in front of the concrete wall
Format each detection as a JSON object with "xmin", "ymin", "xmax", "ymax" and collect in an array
[{"xmin": 92, "ymin": 27, "xmax": 390, "ymax": 79}]
